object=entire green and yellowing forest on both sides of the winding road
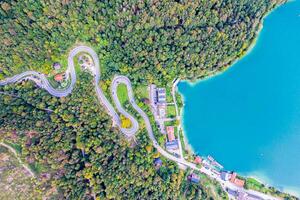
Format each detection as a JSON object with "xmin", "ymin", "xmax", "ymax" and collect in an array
[{"xmin": 0, "ymin": 0, "xmax": 285, "ymax": 199}]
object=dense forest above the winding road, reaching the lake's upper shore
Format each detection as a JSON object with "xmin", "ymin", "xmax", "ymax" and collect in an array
[{"xmin": 0, "ymin": 0, "xmax": 284, "ymax": 82}]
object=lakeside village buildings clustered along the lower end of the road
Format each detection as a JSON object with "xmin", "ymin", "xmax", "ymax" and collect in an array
[{"xmin": 149, "ymin": 84, "xmax": 261, "ymax": 200}]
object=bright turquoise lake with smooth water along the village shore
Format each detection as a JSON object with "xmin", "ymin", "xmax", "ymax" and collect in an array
[{"xmin": 178, "ymin": 1, "xmax": 300, "ymax": 194}]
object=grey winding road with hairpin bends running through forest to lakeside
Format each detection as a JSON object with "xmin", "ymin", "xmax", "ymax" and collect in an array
[{"xmin": 0, "ymin": 45, "xmax": 277, "ymax": 200}]
